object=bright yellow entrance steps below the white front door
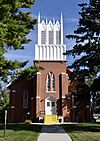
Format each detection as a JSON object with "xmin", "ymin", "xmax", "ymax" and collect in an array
[{"xmin": 44, "ymin": 115, "xmax": 59, "ymax": 124}]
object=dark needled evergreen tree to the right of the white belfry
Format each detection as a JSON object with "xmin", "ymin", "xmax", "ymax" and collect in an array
[{"xmin": 65, "ymin": 0, "xmax": 100, "ymax": 79}]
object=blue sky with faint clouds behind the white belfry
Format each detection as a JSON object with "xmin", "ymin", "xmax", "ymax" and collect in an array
[{"xmin": 5, "ymin": 0, "xmax": 88, "ymax": 67}]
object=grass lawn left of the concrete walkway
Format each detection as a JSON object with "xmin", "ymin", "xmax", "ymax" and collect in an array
[{"xmin": 0, "ymin": 124, "xmax": 42, "ymax": 141}]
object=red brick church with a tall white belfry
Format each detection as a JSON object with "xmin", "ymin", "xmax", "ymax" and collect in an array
[{"xmin": 8, "ymin": 14, "xmax": 89, "ymax": 122}]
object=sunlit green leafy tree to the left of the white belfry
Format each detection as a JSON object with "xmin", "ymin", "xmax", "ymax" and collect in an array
[{"xmin": 0, "ymin": 0, "xmax": 37, "ymax": 81}]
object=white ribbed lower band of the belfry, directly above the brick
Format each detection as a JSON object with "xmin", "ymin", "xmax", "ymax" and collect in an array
[{"xmin": 35, "ymin": 44, "xmax": 66, "ymax": 61}]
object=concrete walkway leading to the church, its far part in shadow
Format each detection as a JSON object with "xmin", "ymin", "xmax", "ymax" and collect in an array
[{"xmin": 38, "ymin": 125, "xmax": 72, "ymax": 141}]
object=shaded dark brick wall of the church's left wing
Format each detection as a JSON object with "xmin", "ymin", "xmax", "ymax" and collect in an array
[{"xmin": 9, "ymin": 80, "xmax": 33, "ymax": 122}]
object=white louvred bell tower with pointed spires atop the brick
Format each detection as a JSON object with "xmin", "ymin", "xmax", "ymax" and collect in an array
[{"xmin": 35, "ymin": 13, "xmax": 66, "ymax": 61}]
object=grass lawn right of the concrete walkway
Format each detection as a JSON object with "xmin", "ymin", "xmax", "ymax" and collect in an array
[{"xmin": 62, "ymin": 123, "xmax": 100, "ymax": 141}]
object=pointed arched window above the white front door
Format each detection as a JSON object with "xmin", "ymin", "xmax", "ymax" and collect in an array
[{"xmin": 46, "ymin": 72, "xmax": 55, "ymax": 91}]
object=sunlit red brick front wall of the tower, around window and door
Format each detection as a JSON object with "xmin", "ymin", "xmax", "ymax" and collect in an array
[{"xmin": 35, "ymin": 61, "xmax": 71, "ymax": 118}]
